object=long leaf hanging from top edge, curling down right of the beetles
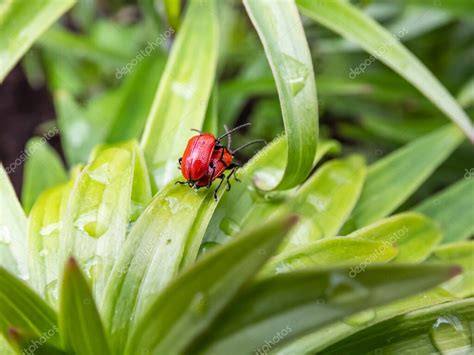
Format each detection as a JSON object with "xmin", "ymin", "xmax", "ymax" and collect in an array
[{"xmin": 244, "ymin": 0, "xmax": 318, "ymax": 190}]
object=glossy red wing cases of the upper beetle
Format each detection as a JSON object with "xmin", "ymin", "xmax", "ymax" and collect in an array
[{"xmin": 180, "ymin": 133, "xmax": 216, "ymax": 181}]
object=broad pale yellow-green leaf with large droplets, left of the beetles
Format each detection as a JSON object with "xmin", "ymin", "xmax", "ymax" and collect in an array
[{"xmin": 60, "ymin": 148, "xmax": 135, "ymax": 300}]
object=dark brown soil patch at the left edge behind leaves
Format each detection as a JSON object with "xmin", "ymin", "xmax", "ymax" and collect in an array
[{"xmin": 0, "ymin": 66, "xmax": 59, "ymax": 195}]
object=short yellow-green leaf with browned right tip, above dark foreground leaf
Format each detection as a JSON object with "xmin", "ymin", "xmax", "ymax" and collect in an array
[{"xmin": 262, "ymin": 237, "xmax": 397, "ymax": 275}]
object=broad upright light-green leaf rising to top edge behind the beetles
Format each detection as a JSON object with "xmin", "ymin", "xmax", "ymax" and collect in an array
[{"xmin": 141, "ymin": 0, "xmax": 218, "ymax": 187}]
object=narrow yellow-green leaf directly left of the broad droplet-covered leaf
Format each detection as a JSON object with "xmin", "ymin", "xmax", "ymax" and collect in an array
[{"xmin": 28, "ymin": 180, "xmax": 73, "ymax": 306}]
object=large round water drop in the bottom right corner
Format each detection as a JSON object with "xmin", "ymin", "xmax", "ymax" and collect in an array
[{"xmin": 430, "ymin": 314, "xmax": 471, "ymax": 354}]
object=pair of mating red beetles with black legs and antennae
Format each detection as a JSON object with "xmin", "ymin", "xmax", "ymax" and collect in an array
[{"xmin": 176, "ymin": 123, "xmax": 264, "ymax": 200}]
